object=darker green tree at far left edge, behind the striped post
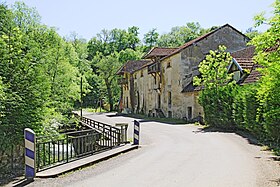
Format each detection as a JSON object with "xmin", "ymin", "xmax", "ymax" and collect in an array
[{"xmin": 0, "ymin": 3, "xmax": 48, "ymax": 150}]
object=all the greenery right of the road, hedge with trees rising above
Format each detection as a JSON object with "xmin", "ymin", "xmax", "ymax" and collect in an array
[{"xmin": 195, "ymin": 0, "xmax": 280, "ymax": 150}]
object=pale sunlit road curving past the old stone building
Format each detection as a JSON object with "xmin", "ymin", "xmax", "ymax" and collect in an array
[{"xmin": 24, "ymin": 114, "xmax": 280, "ymax": 187}]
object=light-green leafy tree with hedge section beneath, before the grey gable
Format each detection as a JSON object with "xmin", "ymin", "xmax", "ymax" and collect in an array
[{"xmin": 194, "ymin": 46, "xmax": 235, "ymax": 128}]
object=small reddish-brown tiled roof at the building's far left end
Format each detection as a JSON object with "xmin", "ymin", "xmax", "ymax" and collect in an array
[{"xmin": 117, "ymin": 60, "xmax": 151, "ymax": 75}]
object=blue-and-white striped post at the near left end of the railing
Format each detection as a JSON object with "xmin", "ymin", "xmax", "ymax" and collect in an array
[{"xmin": 24, "ymin": 128, "xmax": 36, "ymax": 180}]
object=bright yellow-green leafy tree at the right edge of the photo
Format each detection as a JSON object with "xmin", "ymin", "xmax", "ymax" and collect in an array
[{"xmin": 250, "ymin": 0, "xmax": 280, "ymax": 142}]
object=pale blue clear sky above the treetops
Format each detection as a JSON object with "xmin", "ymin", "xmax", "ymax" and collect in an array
[{"xmin": 0, "ymin": 0, "xmax": 274, "ymax": 40}]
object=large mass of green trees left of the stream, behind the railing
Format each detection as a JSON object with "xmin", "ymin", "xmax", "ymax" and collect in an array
[{"xmin": 0, "ymin": 2, "xmax": 80, "ymax": 154}]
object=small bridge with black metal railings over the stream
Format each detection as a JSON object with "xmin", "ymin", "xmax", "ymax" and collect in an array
[{"xmin": 24, "ymin": 116, "xmax": 138, "ymax": 177}]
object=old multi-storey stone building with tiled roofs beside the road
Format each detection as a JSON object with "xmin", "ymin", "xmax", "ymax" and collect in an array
[{"xmin": 118, "ymin": 24, "xmax": 249, "ymax": 120}]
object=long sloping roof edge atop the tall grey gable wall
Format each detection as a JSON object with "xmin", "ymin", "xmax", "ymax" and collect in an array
[{"xmin": 163, "ymin": 24, "xmax": 249, "ymax": 59}]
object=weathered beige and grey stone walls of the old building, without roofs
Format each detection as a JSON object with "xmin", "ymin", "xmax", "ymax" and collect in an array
[{"xmin": 120, "ymin": 25, "xmax": 249, "ymax": 118}]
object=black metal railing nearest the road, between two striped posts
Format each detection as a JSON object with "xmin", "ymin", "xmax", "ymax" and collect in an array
[{"xmin": 36, "ymin": 125, "xmax": 121, "ymax": 170}]
